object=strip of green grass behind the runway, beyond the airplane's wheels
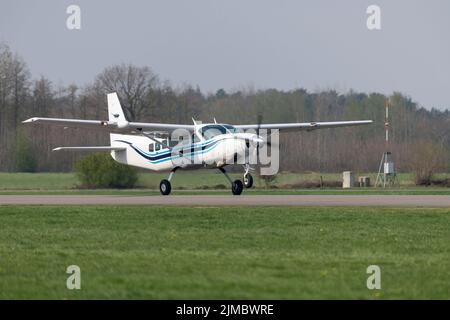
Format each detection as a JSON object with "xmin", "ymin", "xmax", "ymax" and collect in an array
[{"xmin": 0, "ymin": 170, "xmax": 450, "ymax": 195}]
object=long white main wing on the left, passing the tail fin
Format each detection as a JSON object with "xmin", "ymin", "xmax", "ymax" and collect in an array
[{"xmin": 22, "ymin": 117, "xmax": 194, "ymax": 133}]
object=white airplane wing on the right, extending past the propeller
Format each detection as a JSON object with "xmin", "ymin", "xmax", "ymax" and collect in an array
[{"xmin": 234, "ymin": 120, "xmax": 373, "ymax": 132}]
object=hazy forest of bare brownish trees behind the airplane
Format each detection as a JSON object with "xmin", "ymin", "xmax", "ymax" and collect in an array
[{"xmin": 0, "ymin": 44, "xmax": 450, "ymax": 172}]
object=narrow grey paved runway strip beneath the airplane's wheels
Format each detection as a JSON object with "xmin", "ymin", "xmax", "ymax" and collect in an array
[{"xmin": 0, "ymin": 195, "xmax": 450, "ymax": 208}]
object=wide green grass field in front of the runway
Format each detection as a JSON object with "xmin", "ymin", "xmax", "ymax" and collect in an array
[{"xmin": 0, "ymin": 206, "xmax": 450, "ymax": 299}]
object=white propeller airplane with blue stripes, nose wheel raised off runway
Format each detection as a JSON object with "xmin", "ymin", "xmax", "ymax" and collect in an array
[{"xmin": 22, "ymin": 92, "xmax": 373, "ymax": 195}]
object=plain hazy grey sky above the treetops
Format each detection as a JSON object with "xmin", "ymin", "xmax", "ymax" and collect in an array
[{"xmin": 0, "ymin": 0, "xmax": 450, "ymax": 109}]
